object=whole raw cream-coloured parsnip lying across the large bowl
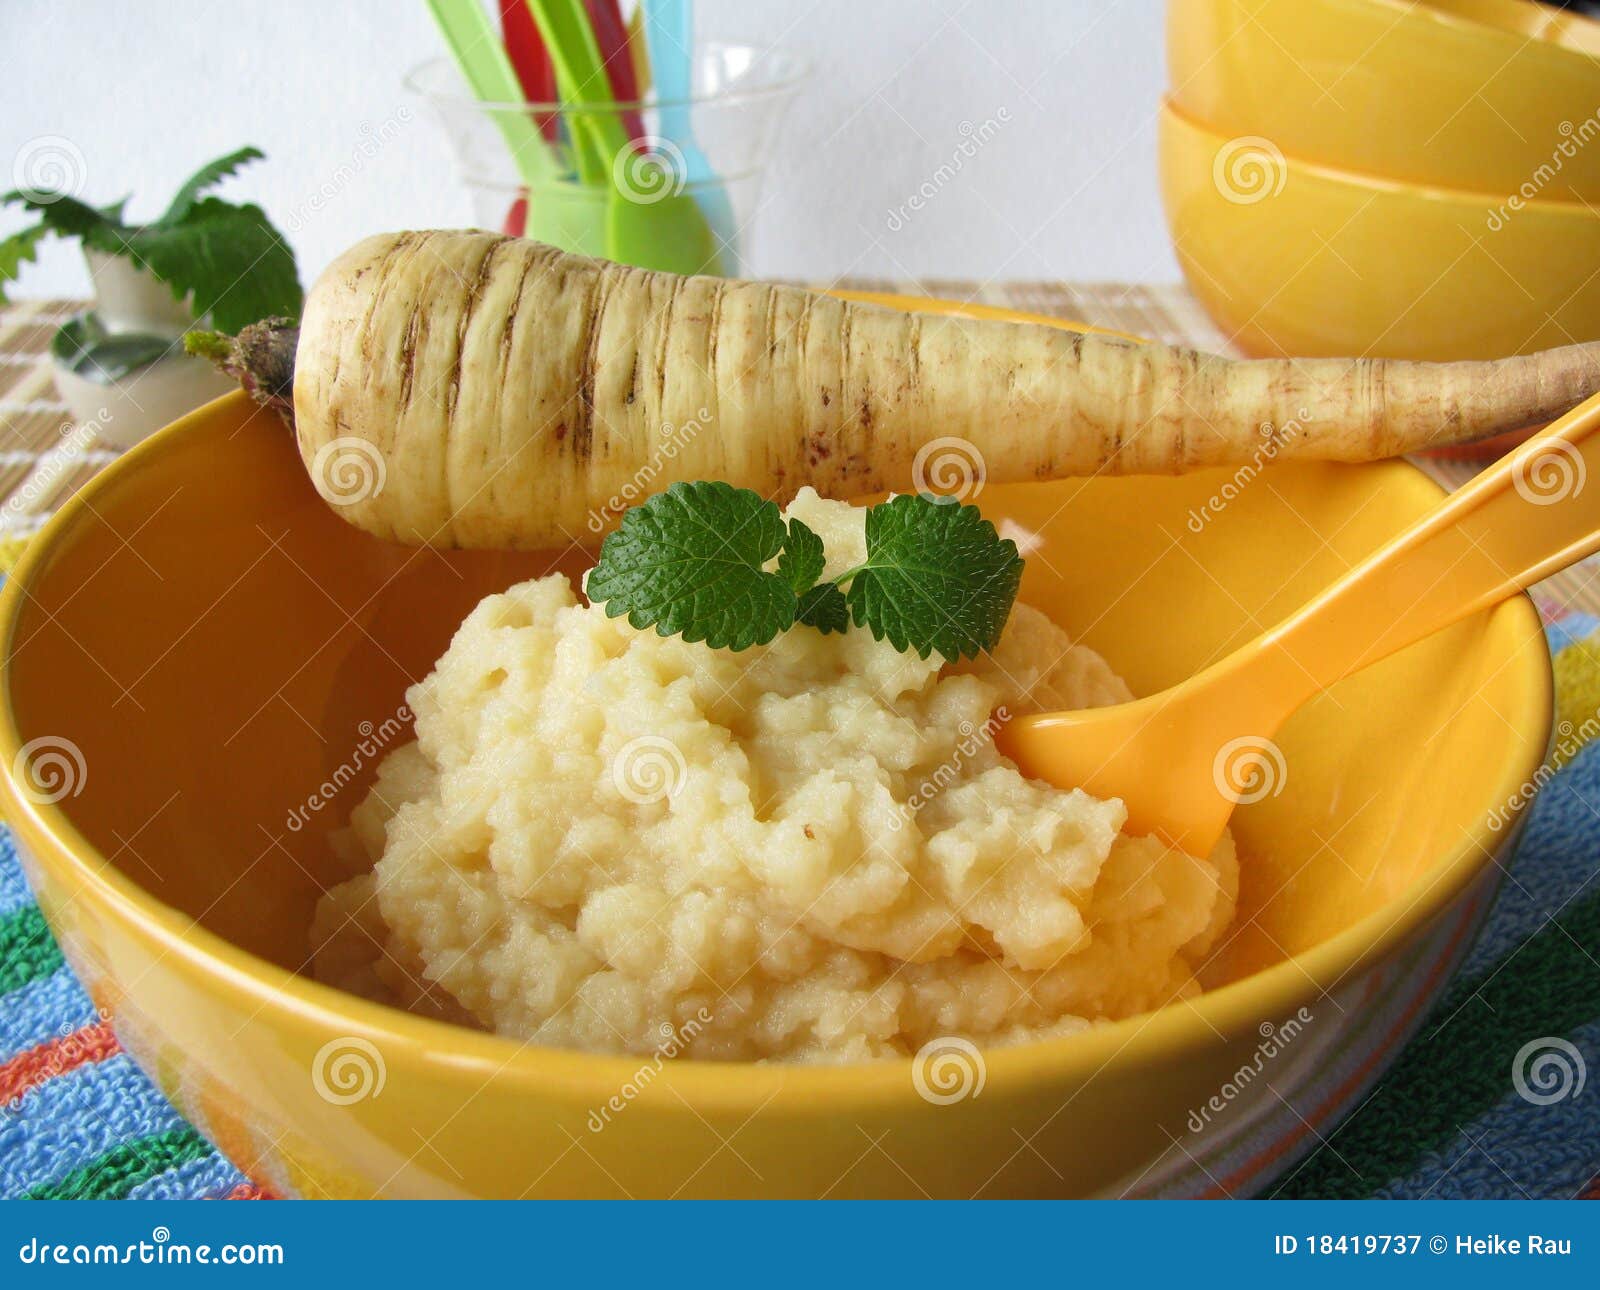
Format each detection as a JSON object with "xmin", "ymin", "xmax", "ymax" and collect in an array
[{"xmin": 196, "ymin": 232, "xmax": 1600, "ymax": 549}]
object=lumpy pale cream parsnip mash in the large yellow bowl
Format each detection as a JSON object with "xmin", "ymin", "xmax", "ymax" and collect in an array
[{"xmin": 314, "ymin": 491, "xmax": 1238, "ymax": 1063}]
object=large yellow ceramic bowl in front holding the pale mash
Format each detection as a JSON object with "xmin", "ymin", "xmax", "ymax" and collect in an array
[{"xmin": 0, "ymin": 336, "xmax": 1550, "ymax": 1197}]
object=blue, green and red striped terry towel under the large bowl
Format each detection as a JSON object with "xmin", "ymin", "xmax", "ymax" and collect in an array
[{"xmin": 0, "ymin": 585, "xmax": 1600, "ymax": 1199}]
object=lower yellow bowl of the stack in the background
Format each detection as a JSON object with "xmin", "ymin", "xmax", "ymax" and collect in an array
[{"xmin": 1160, "ymin": 102, "xmax": 1600, "ymax": 360}]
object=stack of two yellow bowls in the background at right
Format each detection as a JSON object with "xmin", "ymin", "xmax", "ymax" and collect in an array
[{"xmin": 1160, "ymin": 0, "xmax": 1600, "ymax": 359}]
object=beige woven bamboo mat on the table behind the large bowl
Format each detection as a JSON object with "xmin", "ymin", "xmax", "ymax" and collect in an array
[{"xmin": 0, "ymin": 292, "xmax": 1600, "ymax": 616}]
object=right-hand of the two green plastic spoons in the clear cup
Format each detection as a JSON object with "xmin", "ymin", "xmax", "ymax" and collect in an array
[{"xmin": 528, "ymin": 0, "xmax": 722, "ymax": 274}]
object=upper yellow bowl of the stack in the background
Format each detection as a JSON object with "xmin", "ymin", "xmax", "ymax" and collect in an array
[{"xmin": 1166, "ymin": 0, "xmax": 1600, "ymax": 200}]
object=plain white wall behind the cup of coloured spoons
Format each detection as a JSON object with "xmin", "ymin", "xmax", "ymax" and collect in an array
[{"xmin": 0, "ymin": 0, "xmax": 1178, "ymax": 294}]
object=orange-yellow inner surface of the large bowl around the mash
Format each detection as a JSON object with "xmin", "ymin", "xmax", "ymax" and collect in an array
[{"xmin": 6, "ymin": 395, "xmax": 1549, "ymax": 998}]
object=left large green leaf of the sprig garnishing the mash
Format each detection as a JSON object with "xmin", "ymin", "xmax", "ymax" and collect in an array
[{"xmin": 587, "ymin": 482, "xmax": 798, "ymax": 650}]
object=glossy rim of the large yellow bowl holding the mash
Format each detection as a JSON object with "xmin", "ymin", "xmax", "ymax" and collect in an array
[{"xmin": 0, "ymin": 368, "xmax": 1554, "ymax": 1119}]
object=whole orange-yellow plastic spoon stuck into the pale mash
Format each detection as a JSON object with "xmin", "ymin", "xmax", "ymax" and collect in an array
[{"xmin": 997, "ymin": 395, "xmax": 1600, "ymax": 856}]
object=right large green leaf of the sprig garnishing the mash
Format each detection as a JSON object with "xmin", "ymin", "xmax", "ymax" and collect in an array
[{"xmin": 848, "ymin": 493, "xmax": 1022, "ymax": 663}]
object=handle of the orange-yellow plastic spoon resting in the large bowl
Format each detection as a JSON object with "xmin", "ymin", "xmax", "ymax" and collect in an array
[{"xmin": 1262, "ymin": 395, "xmax": 1600, "ymax": 693}]
